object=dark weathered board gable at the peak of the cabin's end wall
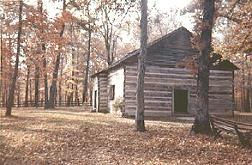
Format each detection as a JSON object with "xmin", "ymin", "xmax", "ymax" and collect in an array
[{"xmin": 146, "ymin": 27, "xmax": 198, "ymax": 67}]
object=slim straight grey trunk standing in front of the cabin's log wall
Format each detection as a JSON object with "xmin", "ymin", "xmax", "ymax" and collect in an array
[{"xmin": 135, "ymin": 0, "xmax": 148, "ymax": 132}]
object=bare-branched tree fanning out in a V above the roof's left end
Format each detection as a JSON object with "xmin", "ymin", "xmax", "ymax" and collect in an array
[{"xmin": 97, "ymin": 0, "xmax": 135, "ymax": 65}]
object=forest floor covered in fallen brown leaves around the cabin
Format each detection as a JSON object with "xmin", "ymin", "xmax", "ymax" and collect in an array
[{"xmin": 0, "ymin": 108, "xmax": 252, "ymax": 165}]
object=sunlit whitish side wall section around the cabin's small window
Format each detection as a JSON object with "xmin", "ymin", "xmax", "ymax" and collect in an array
[{"xmin": 107, "ymin": 68, "xmax": 124, "ymax": 112}]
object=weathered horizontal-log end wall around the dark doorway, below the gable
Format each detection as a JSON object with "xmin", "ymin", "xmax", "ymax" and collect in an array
[{"xmin": 125, "ymin": 65, "xmax": 233, "ymax": 116}]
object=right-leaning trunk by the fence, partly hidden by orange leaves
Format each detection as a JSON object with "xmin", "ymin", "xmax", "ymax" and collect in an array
[{"xmin": 46, "ymin": 0, "xmax": 66, "ymax": 109}]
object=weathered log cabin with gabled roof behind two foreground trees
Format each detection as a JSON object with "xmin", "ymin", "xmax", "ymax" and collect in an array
[{"xmin": 92, "ymin": 27, "xmax": 237, "ymax": 117}]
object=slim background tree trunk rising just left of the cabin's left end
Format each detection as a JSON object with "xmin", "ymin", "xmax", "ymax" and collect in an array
[{"xmin": 82, "ymin": 28, "xmax": 92, "ymax": 103}]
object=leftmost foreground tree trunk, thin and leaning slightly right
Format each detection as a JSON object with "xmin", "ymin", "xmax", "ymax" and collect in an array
[{"xmin": 5, "ymin": 0, "xmax": 23, "ymax": 116}]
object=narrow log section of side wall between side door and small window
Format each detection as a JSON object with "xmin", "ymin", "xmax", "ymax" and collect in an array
[{"xmin": 97, "ymin": 73, "xmax": 108, "ymax": 112}]
